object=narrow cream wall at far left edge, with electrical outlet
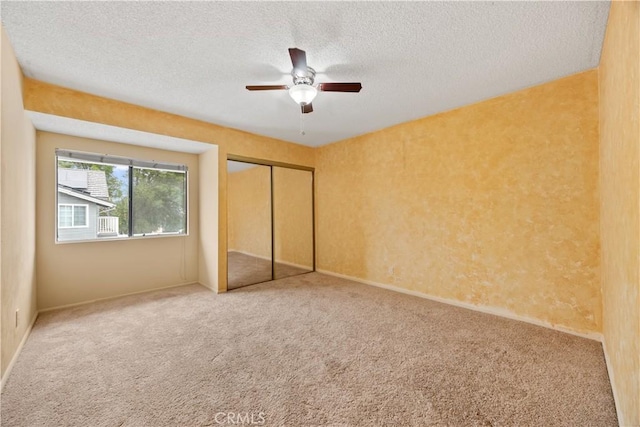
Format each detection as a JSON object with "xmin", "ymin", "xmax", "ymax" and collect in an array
[{"xmin": 0, "ymin": 29, "xmax": 36, "ymax": 382}]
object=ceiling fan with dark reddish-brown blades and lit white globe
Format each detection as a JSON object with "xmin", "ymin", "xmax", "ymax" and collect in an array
[{"xmin": 247, "ymin": 47, "xmax": 362, "ymax": 114}]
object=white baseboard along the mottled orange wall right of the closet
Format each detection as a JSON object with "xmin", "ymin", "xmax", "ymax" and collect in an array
[{"xmin": 316, "ymin": 269, "xmax": 602, "ymax": 342}]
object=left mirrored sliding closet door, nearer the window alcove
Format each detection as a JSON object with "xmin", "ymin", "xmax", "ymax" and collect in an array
[{"xmin": 227, "ymin": 160, "xmax": 272, "ymax": 289}]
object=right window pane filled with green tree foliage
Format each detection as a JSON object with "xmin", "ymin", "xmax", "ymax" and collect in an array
[{"xmin": 132, "ymin": 167, "xmax": 187, "ymax": 235}]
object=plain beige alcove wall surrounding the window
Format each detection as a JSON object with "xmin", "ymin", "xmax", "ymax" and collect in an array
[{"xmin": 36, "ymin": 132, "xmax": 199, "ymax": 310}]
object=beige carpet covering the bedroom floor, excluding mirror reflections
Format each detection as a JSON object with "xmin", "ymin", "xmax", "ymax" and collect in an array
[{"xmin": 2, "ymin": 273, "xmax": 616, "ymax": 427}]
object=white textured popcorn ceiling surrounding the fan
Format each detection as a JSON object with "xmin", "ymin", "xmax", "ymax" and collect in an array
[{"xmin": 0, "ymin": 1, "xmax": 609, "ymax": 146}]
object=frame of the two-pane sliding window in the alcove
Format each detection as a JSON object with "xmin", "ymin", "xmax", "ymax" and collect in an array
[{"xmin": 54, "ymin": 148, "xmax": 190, "ymax": 244}]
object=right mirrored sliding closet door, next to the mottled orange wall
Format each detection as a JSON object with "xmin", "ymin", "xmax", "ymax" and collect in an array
[{"xmin": 273, "ymin": 166, "xmax": 314, "ymax": 279}]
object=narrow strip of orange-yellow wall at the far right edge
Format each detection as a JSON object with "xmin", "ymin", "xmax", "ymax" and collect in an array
[{"xmin": 599, "ymin": 2, "xmax": 640, "ymax": 426}]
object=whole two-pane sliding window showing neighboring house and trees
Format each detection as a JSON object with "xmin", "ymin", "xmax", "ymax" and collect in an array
[{"xmin": 56, "ymin": 150, "xmax": 188, "ymax": 241}]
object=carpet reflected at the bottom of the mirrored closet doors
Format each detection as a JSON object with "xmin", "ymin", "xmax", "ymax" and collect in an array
[{"xmin": 227, "ymin": 251, "xmax": 311, "ymax": 290}]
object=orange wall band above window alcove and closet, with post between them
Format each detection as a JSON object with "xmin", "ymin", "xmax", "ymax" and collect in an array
[{"xmin": 23, "ymin": 78, "xmax": 315, "ymax": 292}]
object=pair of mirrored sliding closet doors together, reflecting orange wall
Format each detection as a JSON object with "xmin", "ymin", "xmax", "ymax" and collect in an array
[{"xmin": 227, "ymin": 156, "xmax": 315, "ymax": 290}]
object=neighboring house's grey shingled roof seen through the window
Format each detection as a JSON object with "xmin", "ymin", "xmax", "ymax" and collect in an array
[{"xmin": 58, "ymin": 168, "xmax": 115, "ymax": 208}]
